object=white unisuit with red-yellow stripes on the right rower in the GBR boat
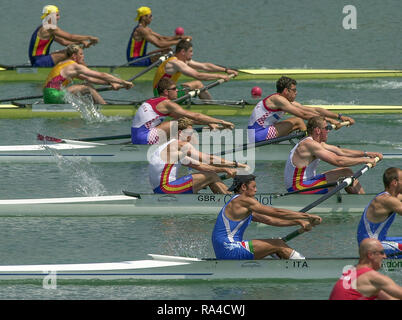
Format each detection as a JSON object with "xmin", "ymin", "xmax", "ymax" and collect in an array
[{"xmin": 284, "ymin": 137, "xmax": 328, "ymax": 193}]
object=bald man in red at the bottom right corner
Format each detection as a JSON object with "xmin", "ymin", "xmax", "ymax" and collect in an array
[{"xmin": 329, "ymin": 239, "xmax": 402, "ymax": 300}]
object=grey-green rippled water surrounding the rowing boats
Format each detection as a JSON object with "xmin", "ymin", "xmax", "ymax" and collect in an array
[{"xmin": 0, "ymin": 0, "xmax": 402, "ymax": 300}]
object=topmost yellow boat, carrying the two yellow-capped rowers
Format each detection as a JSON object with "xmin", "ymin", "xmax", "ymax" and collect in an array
[{"xmin": 0, "ymin": 65, "xmax": 402, "ymax": 82}]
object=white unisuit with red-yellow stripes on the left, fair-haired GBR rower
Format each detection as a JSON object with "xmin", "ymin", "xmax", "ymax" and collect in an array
[{"xmin": 148, "ymin": 139, "xmax": 193, "ymax": 193}]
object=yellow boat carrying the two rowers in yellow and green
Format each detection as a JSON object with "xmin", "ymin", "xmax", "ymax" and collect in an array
[{"xmin": 0, "ymin": 103, "xmax": 402, "ymax": 119}]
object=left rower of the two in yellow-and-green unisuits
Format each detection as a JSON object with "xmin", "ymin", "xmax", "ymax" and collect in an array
[{"xmin": 43, "ymin": 44, "xmax": 133, "ymax": 104}]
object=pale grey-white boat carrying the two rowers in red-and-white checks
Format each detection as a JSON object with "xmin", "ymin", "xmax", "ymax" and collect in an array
[{"xmin": 0, "ymin": 140, "xmax": 402, "ymax": 164}]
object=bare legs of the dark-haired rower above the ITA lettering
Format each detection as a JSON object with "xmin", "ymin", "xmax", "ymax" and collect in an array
[{"xmin": 252, "ymin": 239, "xmax": 294, "ymax": 260}]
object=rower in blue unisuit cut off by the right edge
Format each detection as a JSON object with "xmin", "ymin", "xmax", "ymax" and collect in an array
[{"xmin": 357, "ymin": 167, "xmax": 402, "ymax": 258}]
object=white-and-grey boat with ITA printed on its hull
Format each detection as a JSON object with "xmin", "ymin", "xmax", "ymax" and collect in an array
[{"xmin": 0, "ymin": 254, "xmax": 402, "ymax": 285}]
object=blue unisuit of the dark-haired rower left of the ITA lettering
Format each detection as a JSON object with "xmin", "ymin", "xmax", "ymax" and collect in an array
[{"xmin": 212, "ymin": 194, "xmax": 254, "ymax": 260}]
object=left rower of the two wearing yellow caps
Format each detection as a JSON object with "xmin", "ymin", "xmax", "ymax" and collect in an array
[{"xmin": 29, "ymin": 5, "xmax": 99, "ymax": 67}]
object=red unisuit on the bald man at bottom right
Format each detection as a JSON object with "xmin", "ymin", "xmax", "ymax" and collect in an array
[{"xmin": 329, "ymin": 267, "xmax": 377, "ymax": 300}]
